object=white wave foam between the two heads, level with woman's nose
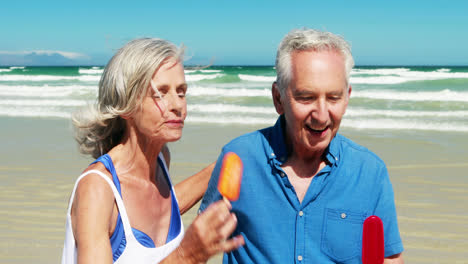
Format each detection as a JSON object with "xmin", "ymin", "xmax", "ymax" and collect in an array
[{"xmin": 188, "ymin": 104, "xmax": 276, "ymax": 115}]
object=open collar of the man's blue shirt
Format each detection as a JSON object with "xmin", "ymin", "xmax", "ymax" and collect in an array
[{"xmin": 268, "ymin": 115, "xmax": 341, "ymax": 165}]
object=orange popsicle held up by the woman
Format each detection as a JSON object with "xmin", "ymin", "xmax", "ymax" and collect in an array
[{"xmin": 218, "ymin": 152, "xmax": 244, "ymax": 201}]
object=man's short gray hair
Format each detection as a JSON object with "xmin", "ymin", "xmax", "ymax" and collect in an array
[{"xmin": 276, "ymin": 28, "xmax": 354, "ymax": 93}]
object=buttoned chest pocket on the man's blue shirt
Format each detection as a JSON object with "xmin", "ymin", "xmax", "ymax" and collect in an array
[{"xmin": 321, "ymin": 208, "xmax": 366, "ymax": 262}]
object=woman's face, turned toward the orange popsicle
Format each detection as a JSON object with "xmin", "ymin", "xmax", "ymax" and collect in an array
[{"xmin": 132, "ymin": 59, "xmax": 187, "ymax": 143}]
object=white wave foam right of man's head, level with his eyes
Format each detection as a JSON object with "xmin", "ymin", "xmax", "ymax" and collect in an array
[{"xmin": 351, "ymin": 89, "xmax": 468, "ymax": 102}]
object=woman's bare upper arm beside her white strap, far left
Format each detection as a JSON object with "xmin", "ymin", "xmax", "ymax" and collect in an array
[{"xmin": 71, "ymin": 174, "xmax": 114, "ymax": 263}]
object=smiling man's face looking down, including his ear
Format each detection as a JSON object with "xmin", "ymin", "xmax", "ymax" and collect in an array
[{"xmin": 273, "ymin": 51, "xmax": 351, "ymax": 158}]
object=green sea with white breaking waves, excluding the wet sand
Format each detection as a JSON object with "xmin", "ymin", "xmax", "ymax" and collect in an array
[{"xmin": 0, "ymin": 66, "xmax": 468, "ymax": 132}]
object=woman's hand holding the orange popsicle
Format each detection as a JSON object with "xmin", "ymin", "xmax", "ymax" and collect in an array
[{"xmin": 163, "ymin": 200, "xmax": 245, "ymax": 263}]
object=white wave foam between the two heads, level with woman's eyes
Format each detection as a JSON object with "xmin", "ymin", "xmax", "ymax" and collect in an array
[{"xmin": 187, "ymin": 86, "xmax": 271, "ymax": 97}]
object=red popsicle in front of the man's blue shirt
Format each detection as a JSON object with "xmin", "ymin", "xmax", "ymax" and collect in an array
[{"xmin": 362, "ymin": 215, "xmax": 385, "ymax": 264}]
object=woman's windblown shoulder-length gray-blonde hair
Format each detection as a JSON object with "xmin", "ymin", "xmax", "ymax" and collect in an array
[{"xmin": 72, "ymin": 38, "xmax": 184, "ymax": 158}]
